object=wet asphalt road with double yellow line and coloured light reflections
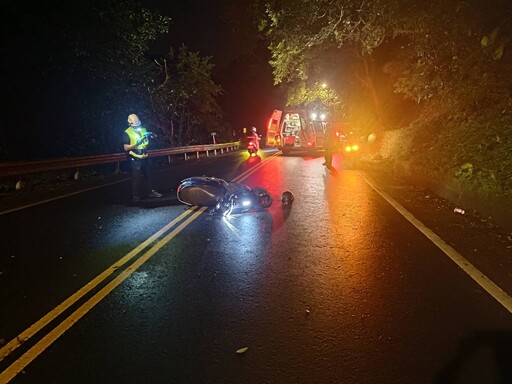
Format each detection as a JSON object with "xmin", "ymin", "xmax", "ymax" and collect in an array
[{"xmin": 0, "ymin": 148, "xmax": 512, "ymax": 384}]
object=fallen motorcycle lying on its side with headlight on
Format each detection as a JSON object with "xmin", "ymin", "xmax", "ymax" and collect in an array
[{"xmin": 177, "ymin": 176, "xmax": 272, "ymax": 216}]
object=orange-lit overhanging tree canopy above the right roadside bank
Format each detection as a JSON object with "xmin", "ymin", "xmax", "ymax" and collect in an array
[{"xmin": 254, "ymin": 0, "xmax": 502, "ymax": 130}]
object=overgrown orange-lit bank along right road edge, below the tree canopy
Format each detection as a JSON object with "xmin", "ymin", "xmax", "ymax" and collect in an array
[{"xmin": 372, "ymin": 110, "xmax": 512, "ymax": 231}]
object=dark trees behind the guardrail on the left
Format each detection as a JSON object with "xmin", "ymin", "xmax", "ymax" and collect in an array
[{"xmin": 0, "ymin": 0, "xmax": 226, "ymax": 160}]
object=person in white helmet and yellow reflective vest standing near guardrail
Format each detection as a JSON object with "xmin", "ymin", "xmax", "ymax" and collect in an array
[{"xmin": 123, "ymin": 113, "xmax": 162, "ymax": 203}]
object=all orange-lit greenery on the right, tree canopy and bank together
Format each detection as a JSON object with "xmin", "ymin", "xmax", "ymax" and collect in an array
[{"xmin": 227, "ymin": 0, "xmax": 512, "ymax": 206}]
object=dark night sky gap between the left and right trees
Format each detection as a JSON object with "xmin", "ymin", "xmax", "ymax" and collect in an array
[{"xmin": 143, "ymin": 0, "xmax": 282, "ymax": 131}]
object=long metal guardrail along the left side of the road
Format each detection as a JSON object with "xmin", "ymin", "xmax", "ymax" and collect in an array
[{"xmin": 0, "ymin": 141, "xmax": 240, "ymax": 177}]
